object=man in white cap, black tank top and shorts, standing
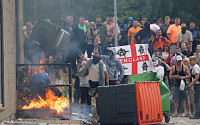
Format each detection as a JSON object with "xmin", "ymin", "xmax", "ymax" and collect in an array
[{"xmin": 169, "ymin": 55, "xmax": 192, "ymax": 117}]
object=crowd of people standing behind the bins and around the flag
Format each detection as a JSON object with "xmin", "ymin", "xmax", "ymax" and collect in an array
[{"xmin": 24, "ymin": 15, "xmax": 200, "ymax": 119}]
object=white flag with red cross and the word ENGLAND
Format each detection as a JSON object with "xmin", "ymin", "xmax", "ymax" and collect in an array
[{"xmin": 115, "ymin": 44, "xmax": 152, "ymax": 75}]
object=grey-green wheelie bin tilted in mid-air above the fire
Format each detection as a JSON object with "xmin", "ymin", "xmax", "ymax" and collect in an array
[{"xmin": 31, "ymin": 20, "xmax": 71, "ymax": 50}]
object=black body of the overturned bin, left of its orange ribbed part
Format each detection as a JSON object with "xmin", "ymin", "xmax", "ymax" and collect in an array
[{"xmin": 96, "ymin": 84, "xmax": 138, "ymax": 125}]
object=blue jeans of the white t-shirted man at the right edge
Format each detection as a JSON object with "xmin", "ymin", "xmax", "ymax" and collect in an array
[{"xmin": 194, "ymin": 84, "xmax": 200, "ymax": 117}]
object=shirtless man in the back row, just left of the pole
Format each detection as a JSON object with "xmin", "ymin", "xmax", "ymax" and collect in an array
[{"xmin": 106, "ymin": 17, "xmax": 115, "ymax": 38}]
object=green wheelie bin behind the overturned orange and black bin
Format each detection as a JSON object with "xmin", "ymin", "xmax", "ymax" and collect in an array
[{"xmin": 128, "ymin": 72, "xmax": 170, "ymax": 123}]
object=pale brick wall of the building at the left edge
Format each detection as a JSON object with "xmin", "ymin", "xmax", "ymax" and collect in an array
[{"xmin": 0, "ymin": 0, "xmax": 22, "ymax": 121}]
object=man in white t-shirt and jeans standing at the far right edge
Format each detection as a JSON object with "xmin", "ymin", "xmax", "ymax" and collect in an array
[{"xmin": 188, "ymin": 56, "xmax": 200, "ymax": 119}]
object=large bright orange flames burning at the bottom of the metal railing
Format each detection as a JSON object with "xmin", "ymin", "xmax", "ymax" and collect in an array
[{"xmin": 22, "ymin": 88, "xmax": 69, "ymax": 115}]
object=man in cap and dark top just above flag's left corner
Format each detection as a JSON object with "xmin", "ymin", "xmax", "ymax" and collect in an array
[{"xmin": 101, "ymin": 34, "xmax": 115, "ymax": 55}]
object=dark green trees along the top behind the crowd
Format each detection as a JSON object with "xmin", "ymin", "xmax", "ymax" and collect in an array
[{"xmin": 24, "ymin": 0, "xmax": 200, "ymax": 26}]
